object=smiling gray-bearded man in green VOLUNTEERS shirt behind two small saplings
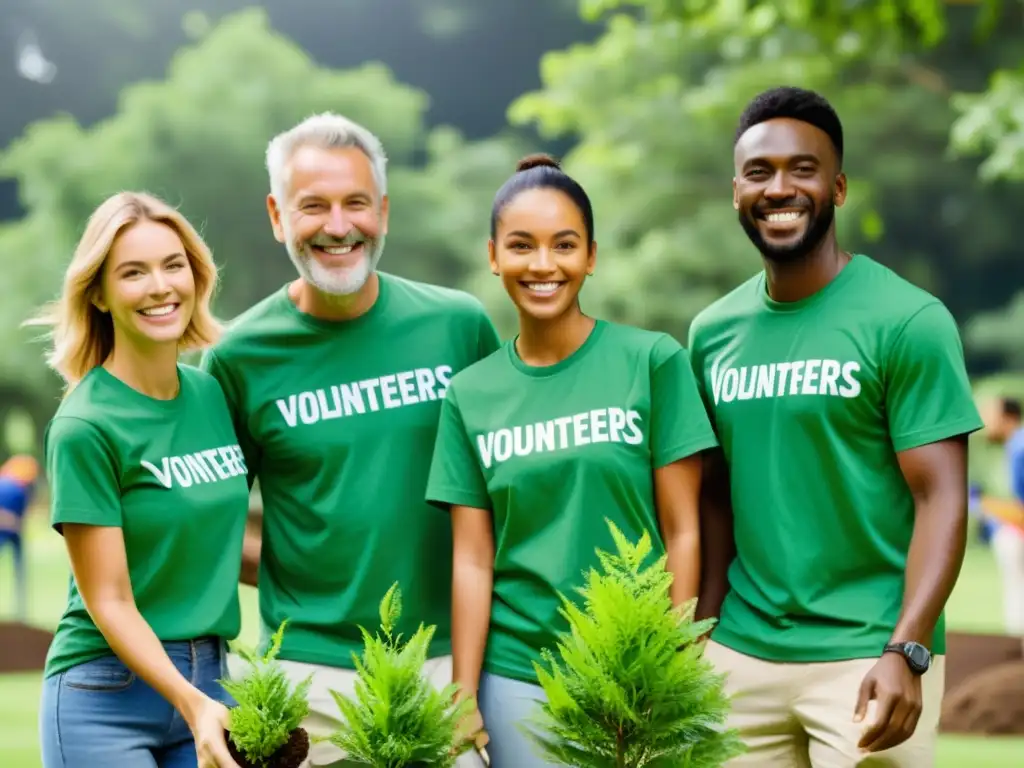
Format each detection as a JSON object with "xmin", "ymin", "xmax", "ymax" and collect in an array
[{"xmin": 198, "ymin": 114, "xmax": 499, "ymax": 766}]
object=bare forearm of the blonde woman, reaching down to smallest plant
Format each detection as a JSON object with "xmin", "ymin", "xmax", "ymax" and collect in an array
[{"xmin": 89, "ymin": 599, "xmax": 203, "ymax": 722}]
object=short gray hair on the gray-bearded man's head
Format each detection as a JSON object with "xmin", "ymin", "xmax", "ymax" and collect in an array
[{"xmin": 266, "ymin": 112, "xmax": 387, "ymax": 204}]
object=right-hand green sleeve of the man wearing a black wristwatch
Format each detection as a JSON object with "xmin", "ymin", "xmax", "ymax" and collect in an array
[{"xmin": 886, "ymin": 302, "xmax": 982, "ymax": 452}]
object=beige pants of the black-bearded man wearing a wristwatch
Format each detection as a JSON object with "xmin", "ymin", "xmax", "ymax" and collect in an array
[{"xmin": 705, "ymin": 641, "xmax": 945, "ymax": 768}]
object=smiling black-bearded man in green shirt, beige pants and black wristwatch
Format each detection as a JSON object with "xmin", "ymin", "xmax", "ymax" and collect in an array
[{"xmin": 689, "ymin": 88, "xmax": 982, "ymax": 768}]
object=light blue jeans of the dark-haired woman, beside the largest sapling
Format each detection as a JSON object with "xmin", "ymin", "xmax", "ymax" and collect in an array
[{"xmin": 479, "ymin": 672, "xmax": 558, "ymax": 768}]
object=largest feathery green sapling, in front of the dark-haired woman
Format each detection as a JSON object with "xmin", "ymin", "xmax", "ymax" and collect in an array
[{"xmin": 524, "ymin": 521, "xmax": 743, "ymax": 768}]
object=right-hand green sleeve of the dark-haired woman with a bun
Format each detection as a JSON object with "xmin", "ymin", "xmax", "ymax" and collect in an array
[{"xmin": 650, "ymin": 337, "xmax": 718, "ymax": 469}]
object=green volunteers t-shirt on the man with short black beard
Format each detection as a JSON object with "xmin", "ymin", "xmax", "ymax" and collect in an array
[{"xmin": 689, "ymin": 255, "xmax": 982, "ymax": 662}]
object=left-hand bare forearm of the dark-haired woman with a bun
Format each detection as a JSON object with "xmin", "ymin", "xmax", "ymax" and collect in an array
[{"xmin": 452, "ymin": 558, "xmax": 494, "ymax": 696}]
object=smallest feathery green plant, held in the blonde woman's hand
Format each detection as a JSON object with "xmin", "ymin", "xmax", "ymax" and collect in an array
[{"xmin": 220, "ymin": 620, "xmax": 312, "ymax": 766}]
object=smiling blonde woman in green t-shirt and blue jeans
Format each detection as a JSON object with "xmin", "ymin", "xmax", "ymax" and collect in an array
[{"xmin": 35, "ymin": 193, "xmax": 249, "ymax": 768}]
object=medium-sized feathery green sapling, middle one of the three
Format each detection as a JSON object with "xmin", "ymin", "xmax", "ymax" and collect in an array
[{"xmin": 330, "ymin": 584, "xmax": 474, "ymax": 768}]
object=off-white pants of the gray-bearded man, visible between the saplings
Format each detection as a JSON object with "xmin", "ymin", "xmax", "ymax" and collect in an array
[{"xmin": 281, "ymin": 656, "xmax": 484, "ymax": 768}]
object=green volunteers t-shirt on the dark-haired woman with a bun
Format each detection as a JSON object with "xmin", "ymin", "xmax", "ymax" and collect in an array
[{"xmin": 419, "ymin": 321, "xmax": 717, "ymax": 682}]
